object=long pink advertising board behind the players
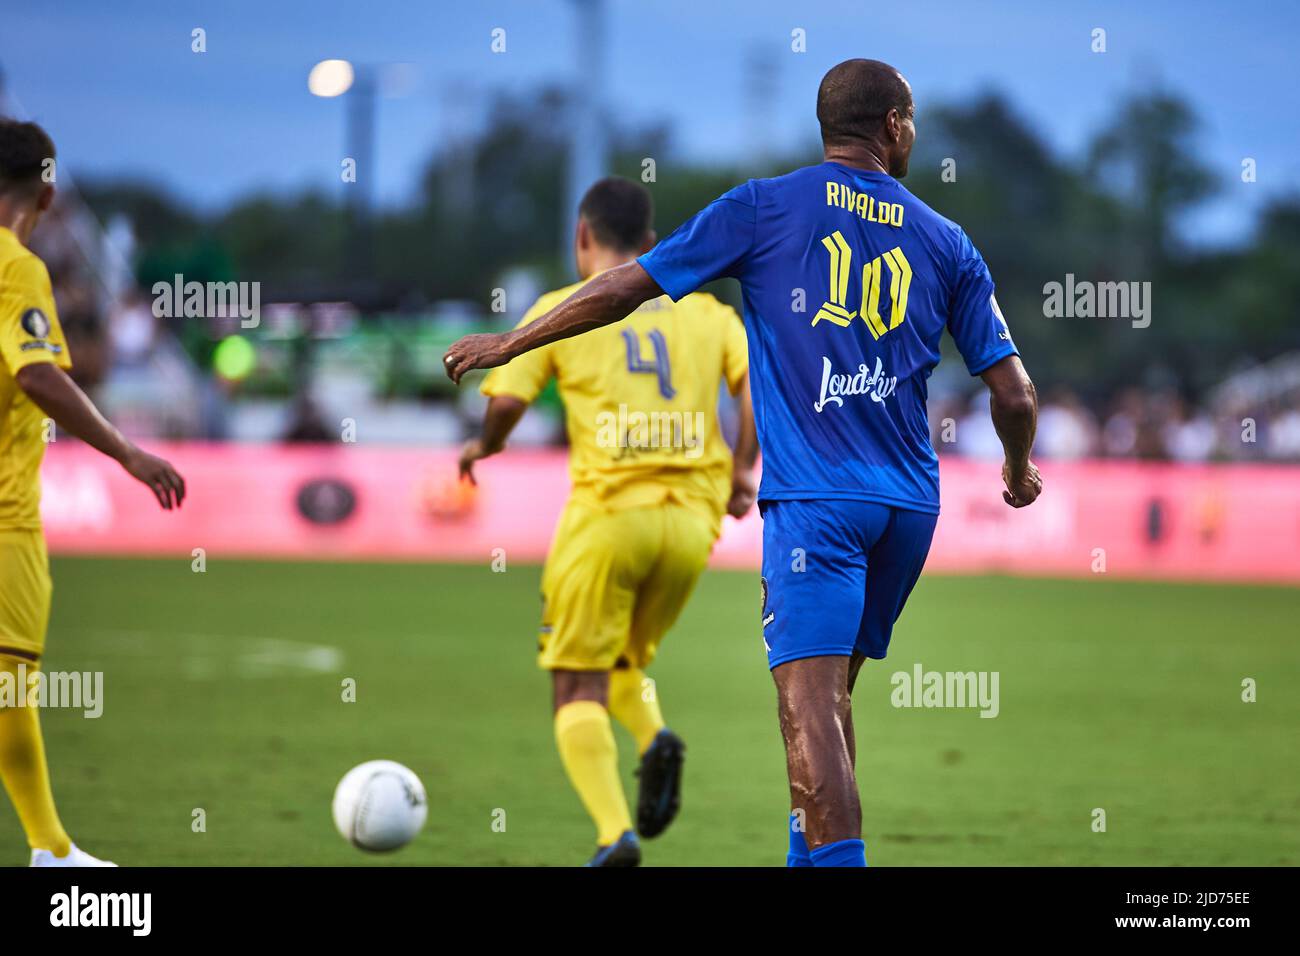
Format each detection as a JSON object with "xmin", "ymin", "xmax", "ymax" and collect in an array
[{"xmin": 42, "ymin": 442, "xmax": 1300, "ymax": 583}]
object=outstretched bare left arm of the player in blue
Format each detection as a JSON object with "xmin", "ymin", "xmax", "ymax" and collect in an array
[{"xmin": 442, "ymin": 261, "xmax": 663, "ymax": 384}]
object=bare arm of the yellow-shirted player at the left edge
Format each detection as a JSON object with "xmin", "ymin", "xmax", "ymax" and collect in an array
[{"xmin": 16, "ymin": 362, "xmax": 185, "ymax": 511}]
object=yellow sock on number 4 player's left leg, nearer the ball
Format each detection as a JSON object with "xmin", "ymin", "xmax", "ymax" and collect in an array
[{"xmin": 555, "ymin": 700, "xmax": 632, "ymax": 847}]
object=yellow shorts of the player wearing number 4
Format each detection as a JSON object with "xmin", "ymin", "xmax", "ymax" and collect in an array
[{"xmin": 537, "ymin": 499, "xmax": 715, "ymax": 671}]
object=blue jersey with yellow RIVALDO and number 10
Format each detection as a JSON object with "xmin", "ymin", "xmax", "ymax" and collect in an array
[{"xmin": 638, "ymin": 163, "xmax": 1015, "ymax": 514}]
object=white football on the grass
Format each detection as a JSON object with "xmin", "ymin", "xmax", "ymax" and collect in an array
[{"xmin": 334, "ymin": 760, "xmax": 429, "ymax": 853}]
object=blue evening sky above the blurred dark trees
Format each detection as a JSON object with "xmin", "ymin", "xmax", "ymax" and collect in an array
[{"xmin": 0, "ymin": 0, "xmax": 1300, "ymax": 243}]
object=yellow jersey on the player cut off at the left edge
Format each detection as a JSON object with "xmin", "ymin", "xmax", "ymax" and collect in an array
[{"xmin": 0, "ymin": 228, "xmax": 73, "ymax": 531}]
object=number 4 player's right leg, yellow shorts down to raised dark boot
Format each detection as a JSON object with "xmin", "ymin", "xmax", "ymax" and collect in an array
[{"xmin": 610, "ymin": 505, "xmax": 715, "ymax": 838}]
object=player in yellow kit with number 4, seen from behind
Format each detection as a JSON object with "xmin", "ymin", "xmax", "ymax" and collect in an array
[{"xmin": 460, "ymin": 178, "xmax": 758, "ymax": 866}]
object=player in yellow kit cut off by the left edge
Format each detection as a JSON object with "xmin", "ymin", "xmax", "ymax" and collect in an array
[{"xmin": 0, "ymin": 117, "xmax": 185, "ymax": 866}]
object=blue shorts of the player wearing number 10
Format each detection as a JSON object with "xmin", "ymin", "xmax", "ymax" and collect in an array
[{"xmin": 759, "ymin": 501, "xmax": 939, "ymax": 667}]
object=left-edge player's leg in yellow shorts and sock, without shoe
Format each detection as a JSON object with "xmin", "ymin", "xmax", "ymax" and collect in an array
[{"xmin": 0, "ymin": 531, "xmax": 72, "ymax": 857}]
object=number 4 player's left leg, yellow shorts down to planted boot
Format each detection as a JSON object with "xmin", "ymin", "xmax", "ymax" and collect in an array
[{"xmin": 538, "ymin": 502, "xmax": 646, "ymax": 866}]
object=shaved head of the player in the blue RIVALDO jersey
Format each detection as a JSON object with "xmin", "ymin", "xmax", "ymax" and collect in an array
[{"xmin": 816, "ymin": 60, "xmax": 915, "ymax": 178}]
